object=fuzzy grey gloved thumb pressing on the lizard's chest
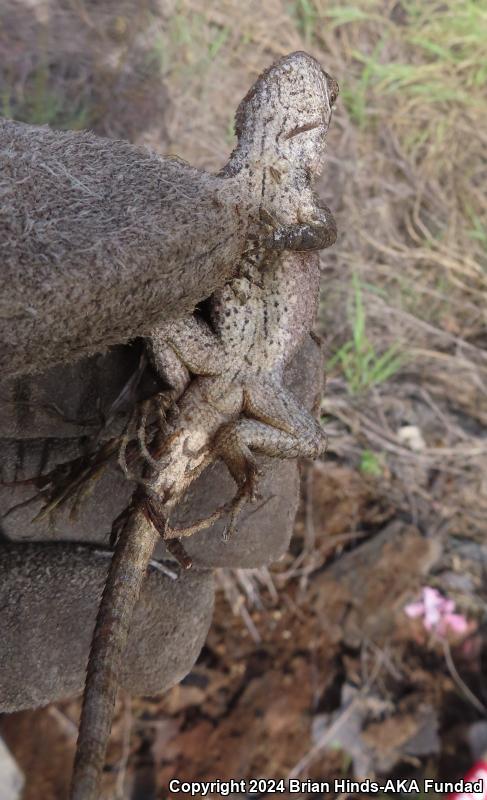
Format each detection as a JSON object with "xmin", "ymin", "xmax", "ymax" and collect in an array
[{"xmin": 0, "ymin": 120, "xmax": 247, "ymax": 374}]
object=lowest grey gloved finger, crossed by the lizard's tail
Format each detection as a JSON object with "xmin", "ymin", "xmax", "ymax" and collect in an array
[{"xmin": 0, "ymin": 543, "xmax": 213, "ymax": 711}]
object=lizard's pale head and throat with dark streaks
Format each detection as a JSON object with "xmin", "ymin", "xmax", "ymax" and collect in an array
[{"xmin": 225, "ymin": 51, "xmax": 338, "ymax": 183}]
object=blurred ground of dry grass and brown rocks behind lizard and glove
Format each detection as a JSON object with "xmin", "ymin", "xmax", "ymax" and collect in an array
[{"xmin": 0, "ymin": 0, "xmax": 487, "ymax": 800}]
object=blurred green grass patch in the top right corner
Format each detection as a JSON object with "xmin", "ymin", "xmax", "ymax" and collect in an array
[{"xmin": 316, "ymin": 0, "xmax": 487, "ymax": 147}]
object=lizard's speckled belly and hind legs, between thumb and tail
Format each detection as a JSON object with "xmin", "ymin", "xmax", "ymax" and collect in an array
[{"xmin": 151, "ymin": 245, "xmax": 334, "ymax": 539}]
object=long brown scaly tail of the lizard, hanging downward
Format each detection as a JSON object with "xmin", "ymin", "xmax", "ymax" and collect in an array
[{"xmin": 70, "ymin": 508, "xmax": 159, "ymax": 800}]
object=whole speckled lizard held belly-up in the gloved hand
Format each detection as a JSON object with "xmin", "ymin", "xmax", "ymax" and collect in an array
[{"xmin": 71, "ymin": 53, "xmax": 338, "ymax": 800}]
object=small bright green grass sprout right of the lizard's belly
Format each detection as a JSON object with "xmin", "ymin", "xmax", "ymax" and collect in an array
[{"xmin": 327, "ymin": 273, "xmax": 404, "ymax": 395}]
